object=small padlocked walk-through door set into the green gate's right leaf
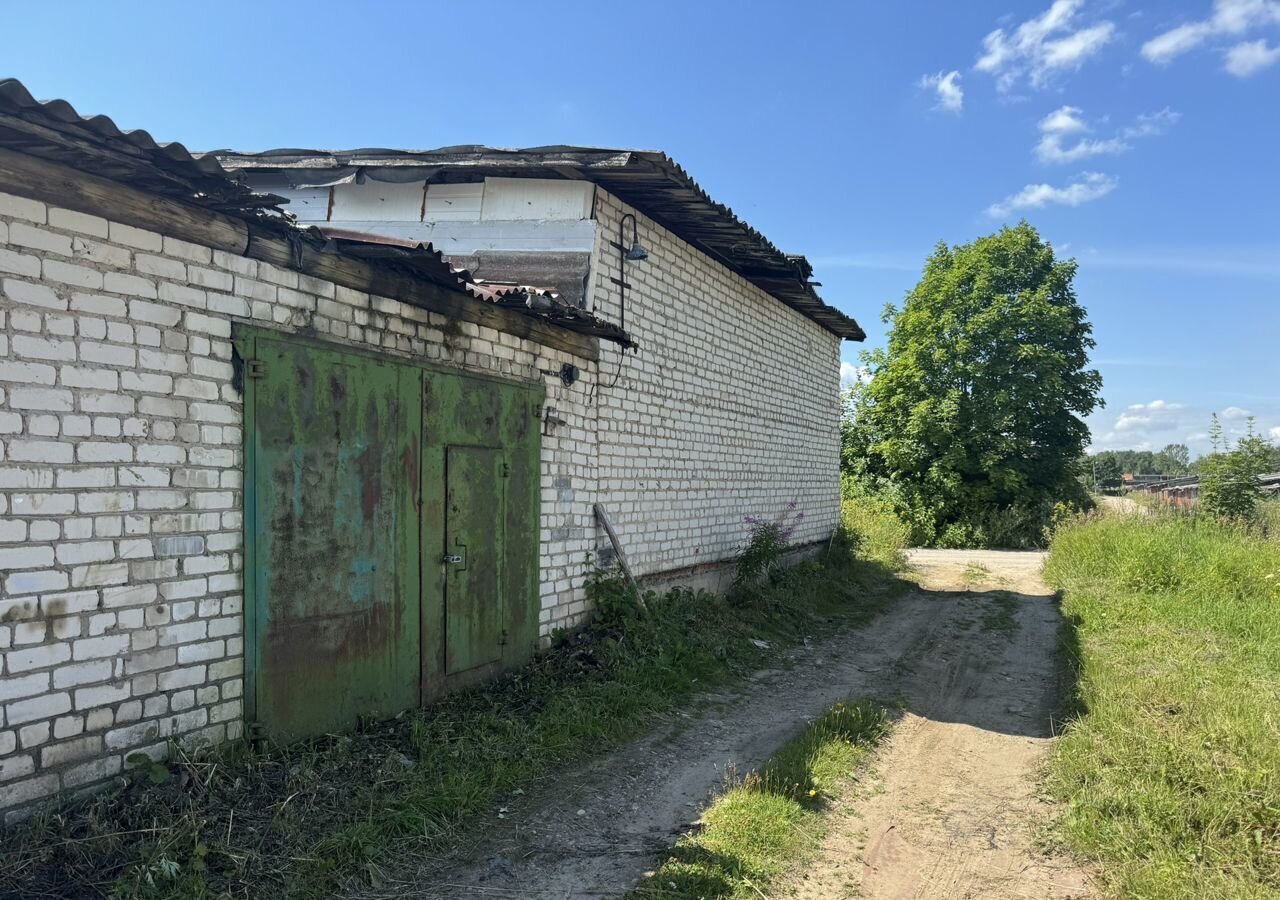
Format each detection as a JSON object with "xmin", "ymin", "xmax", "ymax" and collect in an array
[{"xmin": 443, "ymin": 447, "xmax": 507, "ymax": 675}]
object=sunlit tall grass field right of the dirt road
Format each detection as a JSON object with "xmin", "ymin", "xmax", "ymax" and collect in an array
[{"xmin": 1046, "ymin": 513, "xmax": 1280, "ymax": 900}]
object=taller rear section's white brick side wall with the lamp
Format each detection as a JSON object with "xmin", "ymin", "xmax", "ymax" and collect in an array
[{"xmin": 593, "ymin": 191, "xmax": 840, "ymax": 583}]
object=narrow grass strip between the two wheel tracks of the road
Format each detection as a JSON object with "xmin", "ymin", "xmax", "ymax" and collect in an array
[{"xmin": 630, "ymin": 700, "xmax": 890, "ymax": 900}]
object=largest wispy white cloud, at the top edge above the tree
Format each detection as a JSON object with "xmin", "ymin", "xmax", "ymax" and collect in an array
[{"xmin": 974, "ymin": 0, "xmax": 1115, "ymax": 92}]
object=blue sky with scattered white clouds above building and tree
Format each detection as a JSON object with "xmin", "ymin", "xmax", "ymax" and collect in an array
[{"xmin": 0, "ymin": 0, "xmax": 1280, "ymax": 451}]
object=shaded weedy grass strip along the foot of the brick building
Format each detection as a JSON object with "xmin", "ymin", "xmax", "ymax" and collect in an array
[{"xmin": 0, "ymin": 499, "xmax": 901, "ymax": 900}]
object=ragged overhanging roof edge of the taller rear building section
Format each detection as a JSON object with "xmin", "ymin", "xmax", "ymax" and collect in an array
[{"xmin": 210, "ymin": 146, "xmax": 867, "ymax": 341}]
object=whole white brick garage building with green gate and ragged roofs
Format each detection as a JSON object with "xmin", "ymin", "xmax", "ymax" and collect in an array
[{"xmin": 0, "ymin": 82, "xmax": 861, "ymax": 814}]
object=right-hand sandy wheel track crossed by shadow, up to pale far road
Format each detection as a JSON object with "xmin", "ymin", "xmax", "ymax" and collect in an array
[{"xmin": 778, "ymin": 550, "xmax": 1092, "ymax": 900}]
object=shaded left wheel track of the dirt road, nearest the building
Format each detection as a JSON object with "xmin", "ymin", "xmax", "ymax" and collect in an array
[{"xmin": 356, "ymin": 581, "xmax": 962, "ymax": 900}]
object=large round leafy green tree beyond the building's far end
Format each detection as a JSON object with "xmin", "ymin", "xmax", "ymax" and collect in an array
[{"xmin": 845, "ymin": 221, "xmax": 1102, "ymax": 545}]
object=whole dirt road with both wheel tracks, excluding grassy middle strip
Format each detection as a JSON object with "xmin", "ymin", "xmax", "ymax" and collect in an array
[{"xmin": 361, "ymin": 552, "xmax": 1084, "ymax": 900}]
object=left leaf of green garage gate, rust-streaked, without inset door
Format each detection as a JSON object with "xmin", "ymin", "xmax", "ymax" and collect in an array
[{"xmin": 242, "ymin": 337, "xmax": 422, "ymax": 740}]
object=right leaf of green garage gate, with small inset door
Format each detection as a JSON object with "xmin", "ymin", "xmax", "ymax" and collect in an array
[{"xmin": 422, "ymin": 371, "xmax": 544, "ymax": 698}]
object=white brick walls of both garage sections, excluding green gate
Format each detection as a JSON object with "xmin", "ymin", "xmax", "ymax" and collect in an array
[{"xmin": 0, "ymin": 179, "xmax": 838, "ymax": 814}]
